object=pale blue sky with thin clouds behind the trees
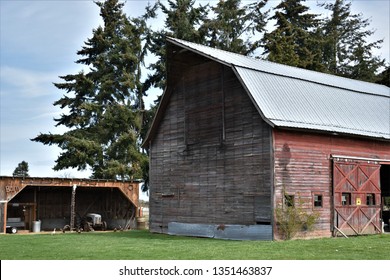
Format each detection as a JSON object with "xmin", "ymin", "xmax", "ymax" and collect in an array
[{"xmin": 0, "ymin": 0, "xmax": 390, "ymax": 177}]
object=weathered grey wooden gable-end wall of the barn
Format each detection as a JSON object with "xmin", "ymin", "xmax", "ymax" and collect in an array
[{"xmin": 149, "ymin": 57, "xmax": 272, "ymax": 232}]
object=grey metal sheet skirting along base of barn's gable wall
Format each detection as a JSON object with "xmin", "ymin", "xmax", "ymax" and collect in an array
[{"xmin": 168, "ymin": 222, "xmax": 272, "ymax": 240}]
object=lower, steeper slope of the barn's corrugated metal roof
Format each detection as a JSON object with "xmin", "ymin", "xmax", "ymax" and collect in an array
[{"xmin": 236, "ymin": 67, "xmax": 390, "ymax": 139}]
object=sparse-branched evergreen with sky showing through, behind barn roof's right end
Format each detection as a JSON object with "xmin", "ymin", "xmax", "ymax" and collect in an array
[{"xmin": 322, "ymin": 0, "xmax": 384, "ymax": 82}]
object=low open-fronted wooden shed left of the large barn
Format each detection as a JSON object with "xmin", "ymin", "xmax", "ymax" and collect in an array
[{"xmin": 0, "ymin": 176, "xmax": 139, "ymax": 232}]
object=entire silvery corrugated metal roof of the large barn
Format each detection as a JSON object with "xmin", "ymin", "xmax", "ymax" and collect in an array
[{"xmin": 168, "ymin": 38, "xmax": 390, "ymax": 139}]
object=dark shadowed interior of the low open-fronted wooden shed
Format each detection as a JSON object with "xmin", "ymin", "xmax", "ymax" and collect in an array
[{"xmin": 7, "ymin": 186, "xmax": 137, "ymax": 231}]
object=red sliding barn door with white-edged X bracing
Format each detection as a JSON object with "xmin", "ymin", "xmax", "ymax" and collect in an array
[{"xmin": 333, "ymin": 160, "xmax": 382, "ymax": 235}]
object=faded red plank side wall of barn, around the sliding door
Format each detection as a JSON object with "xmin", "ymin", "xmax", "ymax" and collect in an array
[{"xmin": 274, "ymin": 129, "xmax": 390, "ymax": 238}]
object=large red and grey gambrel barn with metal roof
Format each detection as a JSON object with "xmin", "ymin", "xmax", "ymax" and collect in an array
[{"xmin": 144, "ymin": 38, "xmax": 390, "ymax": 240}]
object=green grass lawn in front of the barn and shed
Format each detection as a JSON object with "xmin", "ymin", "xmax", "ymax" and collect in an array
[{"xmin": 0, "ymin": 230, "xmax": 390, "ymax": 260}]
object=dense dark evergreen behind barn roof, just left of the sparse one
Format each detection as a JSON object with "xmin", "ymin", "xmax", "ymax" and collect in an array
[{"xmin": 263, "ymin": 0, "xmax": 321, "ymax": 70}]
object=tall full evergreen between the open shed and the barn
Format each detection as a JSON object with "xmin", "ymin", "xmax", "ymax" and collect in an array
[{"xmin": 32, "ymin": 0, "xmax": 147, "ymax": 179}]
